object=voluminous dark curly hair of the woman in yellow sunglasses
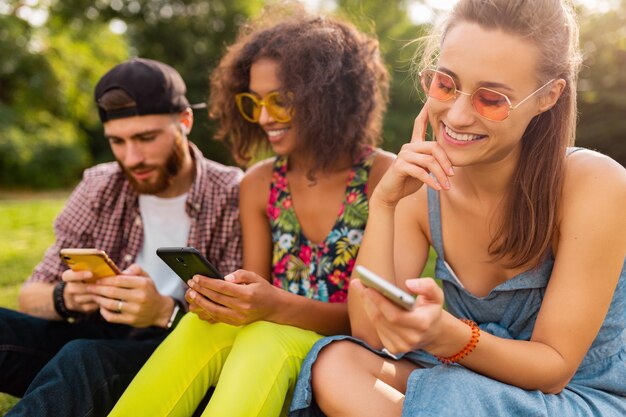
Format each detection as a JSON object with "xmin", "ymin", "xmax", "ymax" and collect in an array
[{"xmin": 209, "ymin": 3, "xmax": 389, "ymax": 174}]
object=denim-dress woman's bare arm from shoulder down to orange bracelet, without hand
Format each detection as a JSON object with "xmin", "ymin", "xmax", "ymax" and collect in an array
[{"xmin": 464, "ymin": 152, "xmax": 626, "ymax": 393}]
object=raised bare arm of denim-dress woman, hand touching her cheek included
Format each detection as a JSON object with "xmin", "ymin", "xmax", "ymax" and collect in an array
[{"xmin": 348, "ymin": 106, "xmax": 451, "ymax": 347}]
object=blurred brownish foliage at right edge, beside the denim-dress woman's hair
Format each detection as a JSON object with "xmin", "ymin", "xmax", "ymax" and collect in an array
[{"xmin": 576, "ymin": 0, "xmax": 626, "ymax": 166}]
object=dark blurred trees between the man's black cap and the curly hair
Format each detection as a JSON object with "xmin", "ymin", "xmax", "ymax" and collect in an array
[{"xmin": 50, "ymin": 0, "xmax": 263, "ymax": 163}]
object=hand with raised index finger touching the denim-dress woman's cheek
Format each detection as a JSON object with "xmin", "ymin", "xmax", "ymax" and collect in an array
[{"xmin": 373, "ymin": 103, "xmax": 454, "ymax": 207}]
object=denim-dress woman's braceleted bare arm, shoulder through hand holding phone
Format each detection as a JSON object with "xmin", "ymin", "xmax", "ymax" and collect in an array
[{"xmin": 358, "ymin": 153, "xmax": 626, "ymax": 393}]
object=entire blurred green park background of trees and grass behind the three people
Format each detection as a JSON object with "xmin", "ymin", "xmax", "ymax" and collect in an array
[{"xmin": 0, "ymin": 0, "xmax": 626, "ymax": 415}]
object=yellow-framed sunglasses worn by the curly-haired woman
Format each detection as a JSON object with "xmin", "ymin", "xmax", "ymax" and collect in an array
[{"xmin": 235, "ymin": 91, "xmax": 293, "ymax": 123}]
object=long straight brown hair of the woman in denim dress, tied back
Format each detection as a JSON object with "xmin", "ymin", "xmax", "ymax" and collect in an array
[{"xmin": 420, "ymin": 0, "xmax": 581, "ymax": 268}]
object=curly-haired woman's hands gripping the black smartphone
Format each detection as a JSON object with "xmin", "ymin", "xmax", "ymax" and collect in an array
[{"xmin": 185, "ymin": 269, "xmax": 277, "ymax": 326}]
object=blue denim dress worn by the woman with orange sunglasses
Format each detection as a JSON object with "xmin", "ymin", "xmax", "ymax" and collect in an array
[{"xmin": 289, "ymin": 189, "xmax": 626, "ymax": 417}]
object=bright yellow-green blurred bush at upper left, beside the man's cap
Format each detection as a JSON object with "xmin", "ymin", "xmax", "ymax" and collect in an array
[{"xmin": 0, "ymin": 1, "xmax": 126, "ymax": 187}]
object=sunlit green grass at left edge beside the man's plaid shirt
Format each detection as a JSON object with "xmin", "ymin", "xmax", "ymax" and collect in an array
[{"xmin": 0, "ymin": 192, "xmax": 68, "ymax": 415}]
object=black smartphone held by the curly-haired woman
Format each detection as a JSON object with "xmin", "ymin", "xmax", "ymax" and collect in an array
[{"xmin": 157, "ymin": 247, "xmax": 224, "ymax": 284}]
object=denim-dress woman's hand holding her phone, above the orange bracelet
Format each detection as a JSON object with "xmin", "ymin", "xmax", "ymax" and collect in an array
[{"xmin": 350, "ymin": 278, "xmax": 443, "ymax": 354}]
